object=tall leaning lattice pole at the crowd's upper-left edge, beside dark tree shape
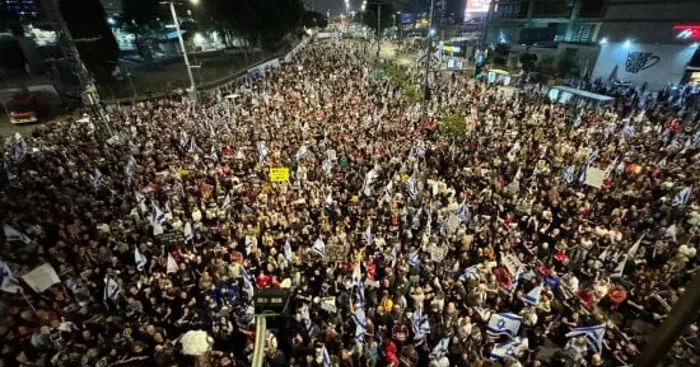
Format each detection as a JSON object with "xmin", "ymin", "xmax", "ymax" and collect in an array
[{"xmin": 42, "ymin": 0, "xmax": 113, "ymax": 142}]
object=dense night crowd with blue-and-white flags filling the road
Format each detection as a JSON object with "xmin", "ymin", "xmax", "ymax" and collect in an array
[{"xmin": 0, "ymin": 41, "xmax": 700, "ymax": 367}]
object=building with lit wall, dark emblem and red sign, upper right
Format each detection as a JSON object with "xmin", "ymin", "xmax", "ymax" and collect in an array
[{"xmin": 484, "ymin": 0, "xmax": 700, "ymax": 90}]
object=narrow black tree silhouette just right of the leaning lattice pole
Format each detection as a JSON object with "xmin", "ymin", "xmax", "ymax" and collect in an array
[{"xmin": 59, "ymin": 0, "xmax": 119, "ymax": 82}]
